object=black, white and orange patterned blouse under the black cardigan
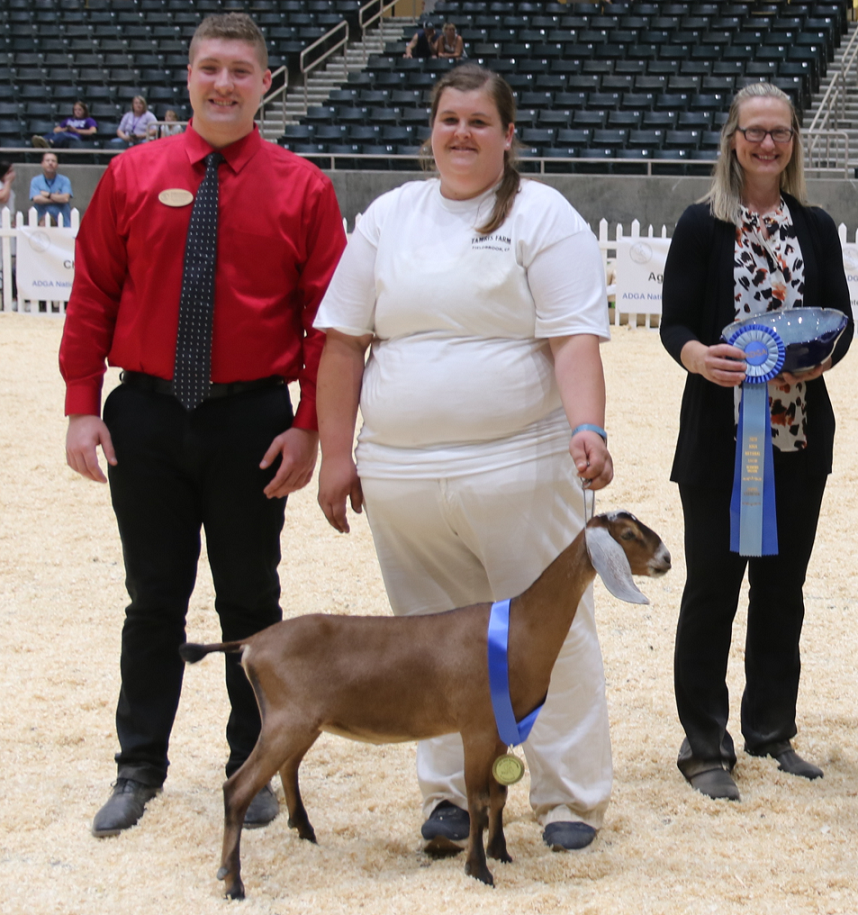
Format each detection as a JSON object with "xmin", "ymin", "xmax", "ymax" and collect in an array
[{"xmin": 733, "ymin": 198, "xmax": 807, "ymax": 451}]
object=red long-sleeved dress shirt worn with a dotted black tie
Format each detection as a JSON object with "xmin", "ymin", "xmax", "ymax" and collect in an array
[{"xmin": 60, "ymin": 121, "xmax": 345, "ymax": 429}]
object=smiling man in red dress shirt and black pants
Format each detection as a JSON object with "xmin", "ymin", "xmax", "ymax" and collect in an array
[{"xmin": 60, "ymin": 13, "xmax": 345, "ymax": 837}]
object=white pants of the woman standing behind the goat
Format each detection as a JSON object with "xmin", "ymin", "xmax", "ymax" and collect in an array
[{"xmin": 361, "ymin": 454, "xmax": 613, "ymax": 829}]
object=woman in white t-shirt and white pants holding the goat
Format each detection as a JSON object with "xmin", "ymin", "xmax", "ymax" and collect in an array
[{"xmin": 316, "ymin": 65, "xmax": 613, "ymax": 853}]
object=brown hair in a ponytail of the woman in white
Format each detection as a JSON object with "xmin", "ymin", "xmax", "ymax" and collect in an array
[{"xmin": 422, "ymin": 64, "xmax": 521, "ymax": 235}]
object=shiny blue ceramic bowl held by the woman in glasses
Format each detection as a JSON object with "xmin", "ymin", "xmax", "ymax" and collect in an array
[{"xmin": 721, "ymin": 308, "xmax": 849, "ymax": 375}]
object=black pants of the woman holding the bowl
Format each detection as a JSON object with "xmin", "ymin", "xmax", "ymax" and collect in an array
[{"xmin": 674, "ymin": 451, "xmax": 827, "ymax": 777}]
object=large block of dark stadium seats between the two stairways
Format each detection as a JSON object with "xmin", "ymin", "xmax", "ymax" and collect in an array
[{"xmin": 281, "ymin": 0, "xmax": 849, "ymax": 174}]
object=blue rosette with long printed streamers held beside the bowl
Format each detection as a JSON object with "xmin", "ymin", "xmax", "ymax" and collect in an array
[{"xmin": 727, "ymin": 324, "xmax": 786, "ymax": 556}]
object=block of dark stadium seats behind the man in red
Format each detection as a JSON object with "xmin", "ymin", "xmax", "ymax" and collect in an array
[{"xmin": 0, "ymin": 0, "xmax": 359, "ymax": 147}]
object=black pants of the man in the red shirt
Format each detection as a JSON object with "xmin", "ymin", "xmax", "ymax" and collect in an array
[{"xmin": 104, "ymin": 385, "xmax": 292, "ymax": 786}]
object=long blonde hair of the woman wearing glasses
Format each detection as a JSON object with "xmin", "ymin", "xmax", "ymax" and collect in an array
[{"xmin": 702, "ymin": 83, "xmax": 807, "ymax": 226}]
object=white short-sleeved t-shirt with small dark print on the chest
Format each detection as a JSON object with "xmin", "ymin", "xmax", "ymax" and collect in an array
[{"xmin": 315, "ymin": 179, "xmax": 609, "ymax": 478}]
